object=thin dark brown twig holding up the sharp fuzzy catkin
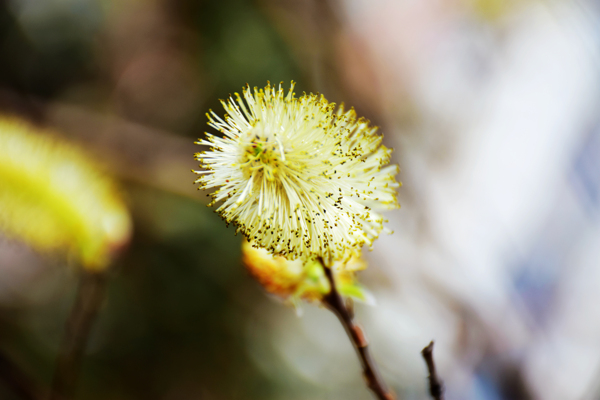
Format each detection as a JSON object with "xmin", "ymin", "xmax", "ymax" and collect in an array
[{"xmin": 319, "ymin": 259, "xmax": 396, "ymax": 400}]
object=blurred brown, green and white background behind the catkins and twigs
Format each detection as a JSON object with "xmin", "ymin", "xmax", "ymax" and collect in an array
[{"xmin": 0, "ymin": 0, "xmax": 600, "ymax": 400}]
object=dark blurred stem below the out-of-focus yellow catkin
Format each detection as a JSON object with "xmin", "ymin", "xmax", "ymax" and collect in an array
[{"xmin": 50, "ymin": 271, "xmax": 106, "ymax": 400}]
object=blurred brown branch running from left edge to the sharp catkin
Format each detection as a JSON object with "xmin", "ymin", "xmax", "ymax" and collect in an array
[{"xmin": 0, "ymin": 89, "xmax": 206, "ymax": 201}]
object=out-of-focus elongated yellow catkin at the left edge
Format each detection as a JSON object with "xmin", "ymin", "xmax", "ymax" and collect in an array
[{"xmin": 0, "ymin": 118, "xmax": 131, "ymax": 270}]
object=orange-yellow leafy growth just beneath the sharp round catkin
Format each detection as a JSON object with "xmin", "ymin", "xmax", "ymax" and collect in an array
[{"xmin": 242, "ymin": 241, "xmax": 372, "ymax": 304}]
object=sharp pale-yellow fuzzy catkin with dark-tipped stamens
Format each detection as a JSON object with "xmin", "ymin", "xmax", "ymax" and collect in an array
[{"xmin": 194, "ymin": 82, "xmax": 399, "ymax": 266}]
